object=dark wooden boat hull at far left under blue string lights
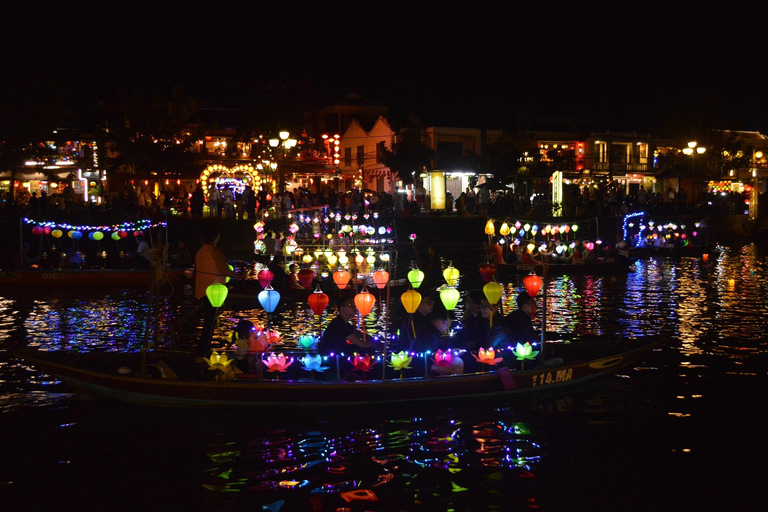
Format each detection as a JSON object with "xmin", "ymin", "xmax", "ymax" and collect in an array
[{"xmin": 0, "ymin": 268, "xmax": 190, "ymax": 286}]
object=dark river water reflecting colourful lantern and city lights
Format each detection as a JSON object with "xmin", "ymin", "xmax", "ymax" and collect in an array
[{"xmin": 0, "ymin": 245, "xmax": 768, "ymax": 511}]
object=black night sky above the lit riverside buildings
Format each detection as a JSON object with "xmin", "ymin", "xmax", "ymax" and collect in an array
[{"xmin": 0, "ymin": 1, "xmax": 768, "ymax": 131}]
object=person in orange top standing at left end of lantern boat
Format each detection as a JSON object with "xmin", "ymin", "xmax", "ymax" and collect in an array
[{"xmin": 195, "ymin": 224, "xmax": 237, "ymax": 356}]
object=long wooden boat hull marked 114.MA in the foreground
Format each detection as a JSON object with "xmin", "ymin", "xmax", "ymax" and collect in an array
[{"xmin": 10, "ymin": 337, "xmax": 663, "ymax": 408}]
